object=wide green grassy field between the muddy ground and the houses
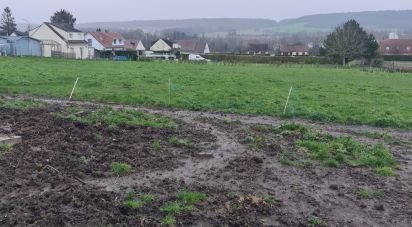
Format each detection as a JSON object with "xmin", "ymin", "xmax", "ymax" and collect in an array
[{"xmin": 0, "ymin": 57, "xmax": 412, "ymax": 129}]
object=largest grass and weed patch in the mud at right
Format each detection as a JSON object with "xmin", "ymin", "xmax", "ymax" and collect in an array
[{"xmin": 297, "ymin": 136, "xmax": 396, "ymax": 176}]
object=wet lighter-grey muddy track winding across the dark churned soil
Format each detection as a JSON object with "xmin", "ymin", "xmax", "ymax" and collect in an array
[{"xmin": 4, "ymin": 96, "xmax": 412, "ymax": 226}]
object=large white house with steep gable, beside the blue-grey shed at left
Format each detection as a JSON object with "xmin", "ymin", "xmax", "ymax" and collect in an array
[{"xmin": 29, "ymin": 22, "xmax": 94, "ymax": 59}]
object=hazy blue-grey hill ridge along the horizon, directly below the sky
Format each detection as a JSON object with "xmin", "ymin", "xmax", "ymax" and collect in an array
[{"xmin": 56, "ymin": 10, "xmax": 412, "ymax": 34}]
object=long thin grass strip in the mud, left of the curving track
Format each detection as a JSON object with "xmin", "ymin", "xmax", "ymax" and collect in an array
[{"xmin": 55, "ymin": 107, "xmax": 176, "ymax": 128}]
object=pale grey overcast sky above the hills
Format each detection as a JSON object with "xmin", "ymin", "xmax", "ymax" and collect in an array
[{"xmin": 0, "ymin": 0, "xmax": 412, "ymax": 23}]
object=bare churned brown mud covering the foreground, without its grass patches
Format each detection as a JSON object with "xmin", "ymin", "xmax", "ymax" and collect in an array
[{"xmin": 0, "ymin": 100, "xmax": 412, "ymax": 227}]
